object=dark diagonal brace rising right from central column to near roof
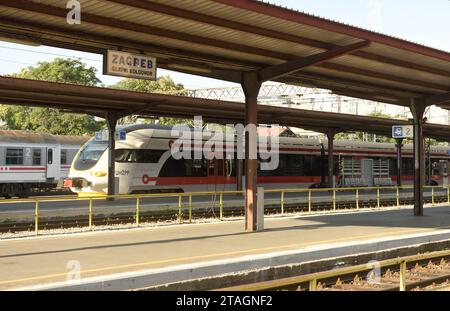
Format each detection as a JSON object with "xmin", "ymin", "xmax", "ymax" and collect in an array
[{"xmin": 258, "ymin": 41, "xmax": 370, "ymax": 81}]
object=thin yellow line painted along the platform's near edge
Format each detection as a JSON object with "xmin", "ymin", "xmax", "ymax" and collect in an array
[{"xmin": 0, "ymin": 226, "xmax": 450, "ymax": 285}]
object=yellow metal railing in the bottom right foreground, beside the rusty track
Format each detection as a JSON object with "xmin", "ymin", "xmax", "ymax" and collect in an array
[{"xmin": 220, "ymin": 250, "xmax": 450, "ymax": 291}]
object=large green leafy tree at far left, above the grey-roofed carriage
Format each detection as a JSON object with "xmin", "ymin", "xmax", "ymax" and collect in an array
[{"xmin": 0, "ymin": 58, "xmax": 103, "ymax": 135}]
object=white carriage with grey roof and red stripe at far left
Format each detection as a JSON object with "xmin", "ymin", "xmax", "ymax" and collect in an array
[{"xmin": 0, "ymin": 130, "xmax": 88, "ymax": 198}]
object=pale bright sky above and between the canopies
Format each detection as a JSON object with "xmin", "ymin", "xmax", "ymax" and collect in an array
[{"xmin": 0, "ymin": 0, "xmax": 450, "ymax": 89}]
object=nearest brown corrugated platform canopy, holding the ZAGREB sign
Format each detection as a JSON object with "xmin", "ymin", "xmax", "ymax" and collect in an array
[{"xmin": 0, "ymin": 0, "xmax": 450, "ymax": 105}]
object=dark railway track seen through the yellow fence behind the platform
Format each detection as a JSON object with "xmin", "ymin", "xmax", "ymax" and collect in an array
[{"xmin": 0, "ymin": 196, "xmax": 448, "ymax": 233}]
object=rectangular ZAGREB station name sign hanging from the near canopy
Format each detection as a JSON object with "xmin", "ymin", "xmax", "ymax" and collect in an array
[{"xmin": 103, "ymin": 50, "xmax": 156, "ymax": 80}]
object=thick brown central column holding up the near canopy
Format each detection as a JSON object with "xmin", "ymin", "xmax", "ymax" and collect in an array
[{"xmin": 241, "ymin": 72, "xmax": 261, "ymax": 232}]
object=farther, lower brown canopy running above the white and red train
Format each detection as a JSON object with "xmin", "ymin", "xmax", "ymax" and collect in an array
[{"xmin": 0, "ymin": 77, "xmax": 450, "ymax": 141}]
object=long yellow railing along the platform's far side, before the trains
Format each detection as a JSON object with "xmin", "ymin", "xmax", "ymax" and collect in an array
[{"xmin": 0, "ymin": 186, "xmax": 450, "ymax": 235}]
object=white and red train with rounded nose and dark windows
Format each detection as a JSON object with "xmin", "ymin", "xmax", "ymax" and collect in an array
[{"xmin": 65, "ymin": 125, "xmax": 450, "ymax": 195}]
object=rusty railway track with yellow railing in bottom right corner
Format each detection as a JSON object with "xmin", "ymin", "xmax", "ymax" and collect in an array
[{"xmin": 220, "ymin": 250, "xmax": 450, "ymax": 292}]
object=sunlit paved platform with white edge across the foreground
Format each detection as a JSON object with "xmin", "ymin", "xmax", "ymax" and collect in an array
[{"xmin": 0, "ymin": 206, "xmax": 450, "ymax": 290}]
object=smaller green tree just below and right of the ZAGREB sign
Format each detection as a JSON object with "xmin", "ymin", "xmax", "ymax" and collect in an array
[{"xmin": 112, "ymin": 76, "xmax": 188, "ymax": 125}]
